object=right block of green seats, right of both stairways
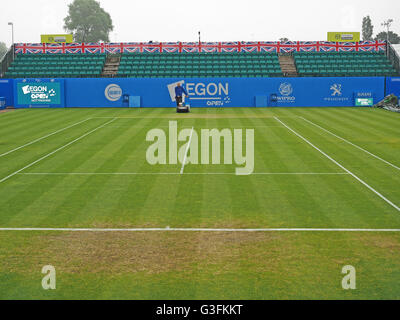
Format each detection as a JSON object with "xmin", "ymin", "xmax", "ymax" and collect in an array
[{"xmin": 294, "ymin": 52, "xmax": 397, "ymax": 77}]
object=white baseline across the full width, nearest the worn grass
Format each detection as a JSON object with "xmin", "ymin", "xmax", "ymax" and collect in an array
[{"xmin": 0, "ymin": 227, "xmax": 400, "ymax": 232}]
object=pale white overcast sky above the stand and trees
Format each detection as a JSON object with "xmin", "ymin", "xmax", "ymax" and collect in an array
[{"xmin": 0, "ymin": 0, "xmax": 400, "ymax": 45}]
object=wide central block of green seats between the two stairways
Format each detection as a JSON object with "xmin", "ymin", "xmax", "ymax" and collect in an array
[{"xmin": 118, "ymin": 53, "xmax": 282, "ymax": 78}]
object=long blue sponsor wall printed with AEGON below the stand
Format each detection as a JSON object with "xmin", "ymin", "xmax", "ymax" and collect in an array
[{"xmin": 5, "ymin": 77, "xmax": 385, "ymax": 107}]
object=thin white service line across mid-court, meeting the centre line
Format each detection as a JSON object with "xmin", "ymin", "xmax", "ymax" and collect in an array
[{"xmin": 18, "ymin": 172, "xmax": 349, "ymax": 176}]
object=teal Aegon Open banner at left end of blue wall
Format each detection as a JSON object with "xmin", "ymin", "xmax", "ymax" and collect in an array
[{"xmin": 14, "ymin": 79, "xmax": 65, "ymax": 107}]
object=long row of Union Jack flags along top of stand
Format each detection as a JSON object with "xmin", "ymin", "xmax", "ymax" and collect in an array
[{"xmin": 15, "ymin": 41, "xmax": 386, "ymax": 54}]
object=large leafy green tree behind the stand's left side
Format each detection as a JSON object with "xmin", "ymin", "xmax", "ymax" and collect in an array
[{"xmin": 64, "ymin": 0, "xmax": 114, "ymax": 42}]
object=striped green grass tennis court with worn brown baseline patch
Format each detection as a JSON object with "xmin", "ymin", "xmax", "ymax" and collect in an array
[{"xmin": 0, "ymin": 108, "xmax": 400, "ymax": 299}]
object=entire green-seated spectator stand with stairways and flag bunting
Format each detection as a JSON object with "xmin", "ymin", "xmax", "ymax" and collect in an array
[{"xmin": 0, "ymin": 41, "xmax": 400, "ymax": 78}]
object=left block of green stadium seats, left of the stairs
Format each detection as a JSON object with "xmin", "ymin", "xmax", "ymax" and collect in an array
[{"xmin": 5, "ymin": 54, "xmax": 106, "ymax": 78}]
